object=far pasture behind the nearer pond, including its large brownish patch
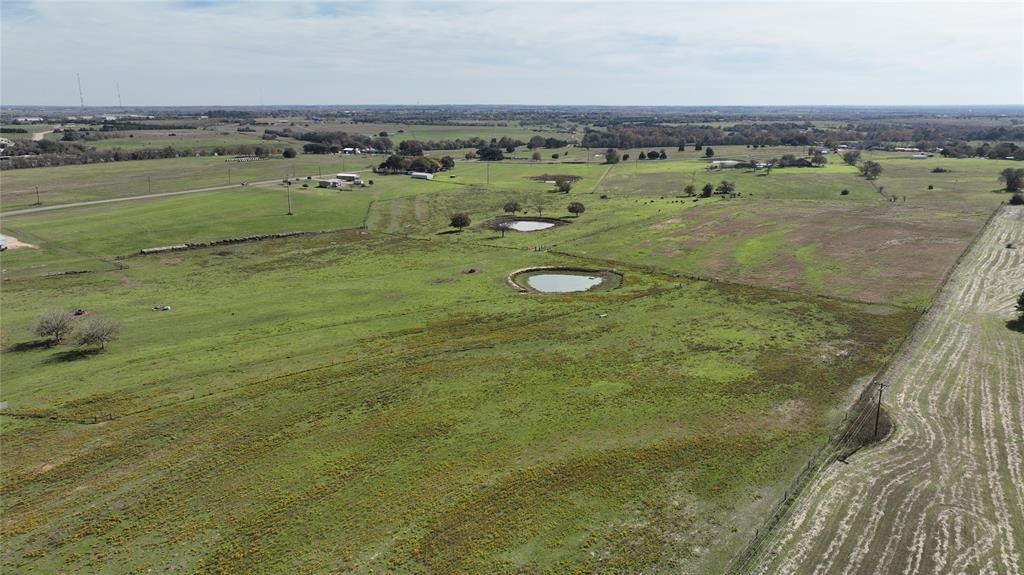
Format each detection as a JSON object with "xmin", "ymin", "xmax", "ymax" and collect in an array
[{"xmin": 368, "ymin": 150, "xmax": 1011, "ymax": 307}]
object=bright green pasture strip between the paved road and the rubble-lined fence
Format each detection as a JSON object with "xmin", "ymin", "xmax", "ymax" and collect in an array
[{"xmin": 2, "ymin": 180, "xmax": 416, "ymax": 279}]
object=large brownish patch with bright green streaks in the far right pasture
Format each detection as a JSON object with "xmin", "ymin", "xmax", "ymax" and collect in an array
[{"xmin": 633, "ymin": 202, "xmax": 987, "ymax": 305}]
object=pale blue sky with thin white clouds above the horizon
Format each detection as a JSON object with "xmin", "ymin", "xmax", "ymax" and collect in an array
[{"xmin": 0, "ymin": 0, "xmax": 1024, "ymax": 105}]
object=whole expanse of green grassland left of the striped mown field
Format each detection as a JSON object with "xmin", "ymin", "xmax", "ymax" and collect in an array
[{"xmin": 0, "ymin": 142, "xmax": 1005, "ymax": 573}]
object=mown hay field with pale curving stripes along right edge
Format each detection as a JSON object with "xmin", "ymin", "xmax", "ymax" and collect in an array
[{"xmin": 754, "ymin": 207, "xmax": 1024, "ymax": 575}]
